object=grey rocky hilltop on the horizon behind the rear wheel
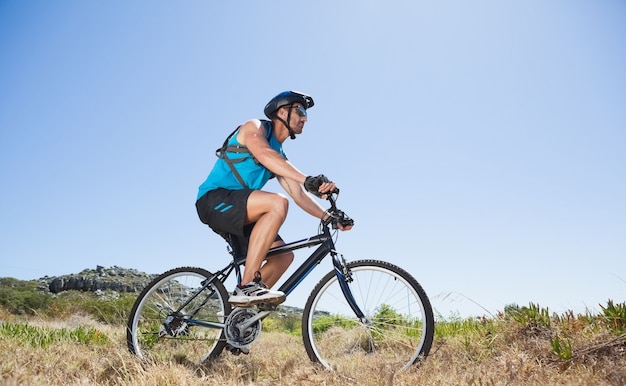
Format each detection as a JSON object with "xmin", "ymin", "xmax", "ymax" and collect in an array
[{"xmin": 39, "ymin": 266, "xmax": 155, "ymax": 294}]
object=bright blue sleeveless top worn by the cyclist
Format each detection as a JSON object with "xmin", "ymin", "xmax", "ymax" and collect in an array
[{"xmin": 197, "ymin": 126, "xmax": 287, "ymax": 199}]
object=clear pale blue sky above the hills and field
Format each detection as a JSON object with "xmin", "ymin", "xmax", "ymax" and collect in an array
[{"xmin": 0, "ymin": 0, "xmax": 626, "ymax": 317}]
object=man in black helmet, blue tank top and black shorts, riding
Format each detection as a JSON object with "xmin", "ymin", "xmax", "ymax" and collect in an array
[{"xmin": 196, "ymin": 91, "xmax": 351, "ymax": 306}]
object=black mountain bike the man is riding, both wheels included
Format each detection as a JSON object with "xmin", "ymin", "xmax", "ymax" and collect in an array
[{"xmin": 127, "ymin": 191, "xmax": 434, "ymax": 371}]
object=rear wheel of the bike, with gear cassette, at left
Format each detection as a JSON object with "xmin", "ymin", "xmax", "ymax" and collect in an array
[{"xmin": 126, "ymin": 267, "xmax": 231, "ymax": 364}]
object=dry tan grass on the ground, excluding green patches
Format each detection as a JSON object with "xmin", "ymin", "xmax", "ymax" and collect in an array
[{"xmin": 0, "ymin": 314, "xmax": 626, "ymax": 386}]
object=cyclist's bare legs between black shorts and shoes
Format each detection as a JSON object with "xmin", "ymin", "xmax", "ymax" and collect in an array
[{"xmin": 241, "ymin": 190, "xmax": 293, "ymax": 287}]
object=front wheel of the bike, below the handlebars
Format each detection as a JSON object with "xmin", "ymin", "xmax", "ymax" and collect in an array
[{"xmin": 302, "ymin": 260, "xmax": 435, "ymax": 374}]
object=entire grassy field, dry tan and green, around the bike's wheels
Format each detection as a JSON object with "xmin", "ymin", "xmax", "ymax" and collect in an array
[{"xmin": 0, "ymin": 294, "xmax": 626, "ymax": 386}]
